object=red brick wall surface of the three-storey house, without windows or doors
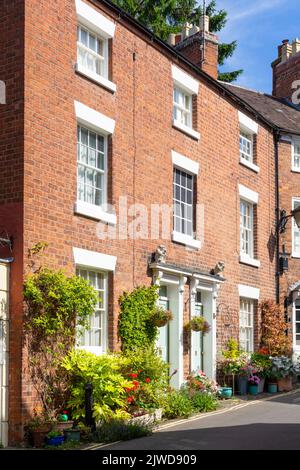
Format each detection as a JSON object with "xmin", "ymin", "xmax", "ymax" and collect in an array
[{"xmin": 0, "ymin": 0, "xmax": 297, "ymax": 443}]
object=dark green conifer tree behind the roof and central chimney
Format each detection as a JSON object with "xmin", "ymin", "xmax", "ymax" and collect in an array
[{"xmin": 114, "ymin": 0, "xmax": 243, "ymax": 82}]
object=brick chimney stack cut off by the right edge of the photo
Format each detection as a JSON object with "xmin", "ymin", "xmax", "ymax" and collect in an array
[{"xmin": 272, "ymin": 39, "xmax": 300, "ymax": 102}]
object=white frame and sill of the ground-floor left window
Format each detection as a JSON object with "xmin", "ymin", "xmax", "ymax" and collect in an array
[{"xmin": 76, "ymin": 265, "xmax": 108, "ymax": 356}]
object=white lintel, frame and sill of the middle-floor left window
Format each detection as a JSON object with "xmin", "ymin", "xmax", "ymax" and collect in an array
[{"xmin": 74, "ymin": 101, "xmax": 117, "ymax": 225}]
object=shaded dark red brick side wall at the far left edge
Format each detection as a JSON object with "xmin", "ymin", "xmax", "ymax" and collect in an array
[{"xmin": 0, "ymin": 0, "xmax": 24, "ymax": 441}]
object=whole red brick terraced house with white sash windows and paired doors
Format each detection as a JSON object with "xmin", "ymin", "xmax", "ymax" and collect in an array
[{"xmin": 0, "ymin": 0, "xmax": 300, "ymax": 445}]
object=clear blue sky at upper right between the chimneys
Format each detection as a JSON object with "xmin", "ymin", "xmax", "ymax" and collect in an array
[{"xmin": 213, "ymin": 0, "xmax": 300, "ymax": 93}]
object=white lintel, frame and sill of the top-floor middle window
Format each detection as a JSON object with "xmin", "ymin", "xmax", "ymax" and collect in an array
[{"xmin": 172, "ymin": 65, "xmax": 200, "ymax": 140}]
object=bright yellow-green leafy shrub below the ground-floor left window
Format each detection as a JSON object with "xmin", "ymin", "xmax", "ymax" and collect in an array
[{"xmin": 62, "ymin": 350, "xmax": 132, "ymax": 421}]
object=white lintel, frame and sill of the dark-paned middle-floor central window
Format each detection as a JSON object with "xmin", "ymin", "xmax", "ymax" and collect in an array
[{"xmin": 172, "ymin": 150, "xmax": 201, "ymax": 249}]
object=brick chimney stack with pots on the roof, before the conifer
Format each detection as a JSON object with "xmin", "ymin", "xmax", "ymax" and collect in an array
[{"xmin": 168, "ymin": 15, "xmax": 218, "ymax": 80}]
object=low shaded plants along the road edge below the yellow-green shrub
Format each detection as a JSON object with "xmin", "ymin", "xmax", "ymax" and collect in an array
[{"xmin": 94, "ymin": 419, "xmax": 152, "ymax": 442}]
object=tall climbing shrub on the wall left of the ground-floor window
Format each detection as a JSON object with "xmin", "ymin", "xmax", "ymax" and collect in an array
[{"xmin": 23, "ymin": 266, "xmax": 97, "ymax": 418}]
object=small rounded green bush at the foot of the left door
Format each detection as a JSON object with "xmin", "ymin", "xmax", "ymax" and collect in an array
[{"xmin": 164, "ymin": 390, "xmax": 194, "ymax": 419}]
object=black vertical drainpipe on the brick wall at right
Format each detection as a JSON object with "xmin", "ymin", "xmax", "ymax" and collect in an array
[{"xmin": 274, "ymin": 130, "xmax": 280, "ymax": 304}]
